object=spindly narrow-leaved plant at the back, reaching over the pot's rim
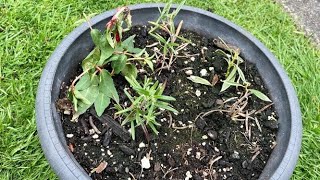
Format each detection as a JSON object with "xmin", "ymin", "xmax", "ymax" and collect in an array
[{"xmin": 149, "ymin": 0, "xmax": 191, "ymax": 69}]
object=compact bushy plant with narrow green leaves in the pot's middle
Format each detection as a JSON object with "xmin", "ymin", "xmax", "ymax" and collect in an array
[{"xmin": 115, "ymin": 77, "xmax": 178, "ymax": 141}]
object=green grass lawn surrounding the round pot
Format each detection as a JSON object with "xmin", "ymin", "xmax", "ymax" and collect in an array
[{"xmin": 0, "ymin": 0, "xmax": 320, "ymax": 179}]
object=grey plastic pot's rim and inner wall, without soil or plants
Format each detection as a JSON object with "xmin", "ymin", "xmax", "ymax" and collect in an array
[{"xmin": 36, "ymin": 4, "xmax": 302, "ymax": 180}]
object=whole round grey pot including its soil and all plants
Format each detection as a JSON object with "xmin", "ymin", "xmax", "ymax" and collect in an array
[{"xmin": 37, "ymin": 1, "xmax": 299, "ymax": 179}]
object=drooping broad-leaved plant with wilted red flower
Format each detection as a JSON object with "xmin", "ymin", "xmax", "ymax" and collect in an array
[{"xmin": 69, "ymin": 7, "xmax": 153, "ymax": 121}]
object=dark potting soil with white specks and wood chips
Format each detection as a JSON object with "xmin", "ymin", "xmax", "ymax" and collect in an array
[{"xmin": 60, "ymin": 27, "xmax": 278, "ymax": 180}]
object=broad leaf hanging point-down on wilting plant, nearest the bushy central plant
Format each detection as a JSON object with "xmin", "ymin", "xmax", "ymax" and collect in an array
[{"xmin": 99, "ymin": 69, "xmax": 119, "ymax": 103}]
